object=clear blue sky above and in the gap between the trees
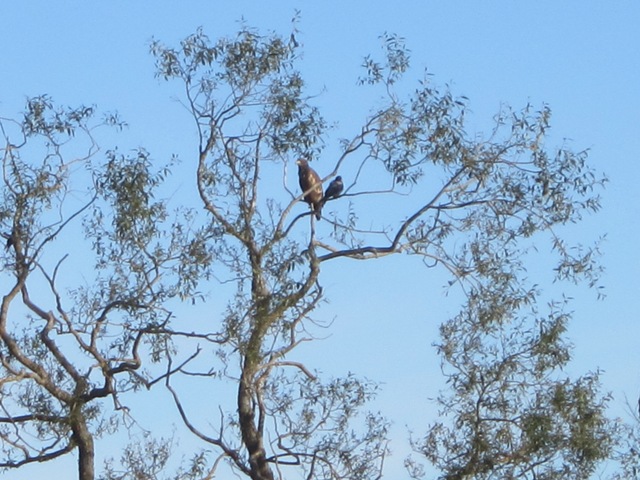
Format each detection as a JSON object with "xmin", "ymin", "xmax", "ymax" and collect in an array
[{"xmin": 0, "ymin": 0, "xmax": 640, "ymax": 479}]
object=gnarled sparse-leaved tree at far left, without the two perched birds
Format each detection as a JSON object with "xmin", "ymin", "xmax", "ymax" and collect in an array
[{"xmin": 0, "ymin": 96, "xmax": 207, "ymax": 480}]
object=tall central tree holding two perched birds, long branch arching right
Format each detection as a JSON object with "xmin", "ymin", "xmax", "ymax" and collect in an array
[{"xmin": 151, "ymin": 27, "xmax": 613, "ymax": 480}]
